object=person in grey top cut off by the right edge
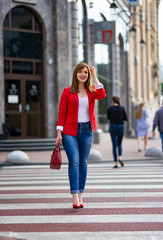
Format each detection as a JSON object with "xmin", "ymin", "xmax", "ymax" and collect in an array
[{"xmin": 152, "ymin": 101, "xmax": 163, "ymax": 152}]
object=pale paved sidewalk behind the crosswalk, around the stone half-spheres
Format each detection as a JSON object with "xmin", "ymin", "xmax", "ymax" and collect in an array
[{"xmin": 0, "ymin": 132, "xmax": 161, "ymax": 163}]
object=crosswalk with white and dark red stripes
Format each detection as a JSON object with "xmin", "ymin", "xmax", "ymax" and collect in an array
[{"xmin": 0, "ymin": 160, "xmax": 163, "ymax": 240}]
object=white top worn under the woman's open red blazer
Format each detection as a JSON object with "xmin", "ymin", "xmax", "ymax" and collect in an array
[{"xmin": 78, "ymin": 96, "xmax": 90, "ymax": 123}]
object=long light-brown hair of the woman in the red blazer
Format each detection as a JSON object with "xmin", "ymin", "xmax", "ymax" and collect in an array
[{"xmin": 71, "ymin": 63, "xmax": 95, "ymax": 93}]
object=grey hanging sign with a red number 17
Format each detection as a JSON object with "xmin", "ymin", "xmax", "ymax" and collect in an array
[{"xmin": 94, "ymin": 21, "xmax": 115, "ymax": 44}]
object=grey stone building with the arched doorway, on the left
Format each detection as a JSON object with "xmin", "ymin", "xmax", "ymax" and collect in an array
[{"xmin": 0, "ymin": 0, "xmax": 78, "ymax": 139}]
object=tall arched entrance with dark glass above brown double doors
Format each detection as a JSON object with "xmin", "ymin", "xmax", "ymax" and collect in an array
[{"xmin": 4, "ymin": 6, "xmax": 44, "ymax": 138}]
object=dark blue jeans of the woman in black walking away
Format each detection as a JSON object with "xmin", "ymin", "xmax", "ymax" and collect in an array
[{"xmin": 109, "ymin": 124, "xmax": 124, "ymax": 162}]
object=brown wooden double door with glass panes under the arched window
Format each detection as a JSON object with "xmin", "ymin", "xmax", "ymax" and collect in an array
[{"xmin": 5, "ymin": 77, "xmax": 43, "ymax": 138}]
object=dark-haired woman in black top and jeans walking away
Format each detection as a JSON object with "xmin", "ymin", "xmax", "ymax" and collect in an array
[{"xmin": 107, "ymin": 96, "xmax": 127, "ymax": 168}]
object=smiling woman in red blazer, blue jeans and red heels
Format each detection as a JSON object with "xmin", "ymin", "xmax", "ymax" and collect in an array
[{"xmin": 56, "ymin": 63, "xmax": 106, "ymax": 208}]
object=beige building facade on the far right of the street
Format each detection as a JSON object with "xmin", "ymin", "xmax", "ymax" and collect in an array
[{"xmin": 129, "ymin": 0, "xmax": 161, "ymax": 134}]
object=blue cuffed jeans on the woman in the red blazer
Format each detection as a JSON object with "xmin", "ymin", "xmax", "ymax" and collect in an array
[{"xmin": 62, "ymin": 122, "xmax": 93, "ymax": 194}]
